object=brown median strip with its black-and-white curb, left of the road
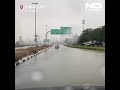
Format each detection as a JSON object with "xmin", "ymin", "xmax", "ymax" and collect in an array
[{"xmin": 15, "ymin": 45, "xmax": 50, "ymax": 66}]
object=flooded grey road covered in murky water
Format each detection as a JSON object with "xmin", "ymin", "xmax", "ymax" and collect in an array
[{"xmin": 15, "ymin": 46, "xmax": 105, "ymax": 88}]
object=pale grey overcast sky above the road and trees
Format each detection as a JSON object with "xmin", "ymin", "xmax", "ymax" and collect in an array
[{"xmin": 15, "ymin": 0, "xmax": 105, "ymax": 41}]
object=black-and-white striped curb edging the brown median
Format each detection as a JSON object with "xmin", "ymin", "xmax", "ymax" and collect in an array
[{"xmin": 15, "ymin": 47, "xmax": 49, "ymax": 67}]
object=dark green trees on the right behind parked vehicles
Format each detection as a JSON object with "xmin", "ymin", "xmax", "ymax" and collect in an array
[{"xmin": 78, "ymin": 25, "xmax": 105, "ymax": 44}]
